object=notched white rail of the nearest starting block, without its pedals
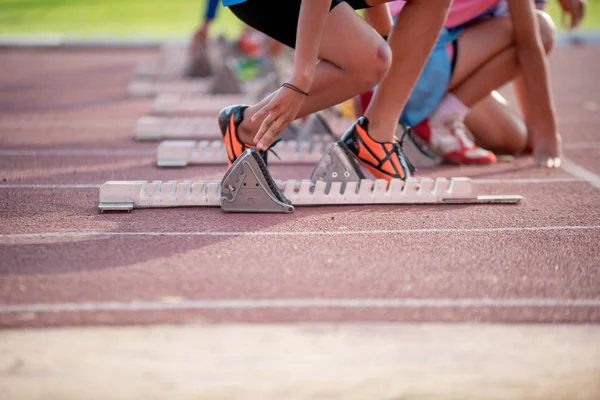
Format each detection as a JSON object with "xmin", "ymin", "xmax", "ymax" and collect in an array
[{"xmin": 98, "ymin": 178, "xmax": 522, "ymax": 211}]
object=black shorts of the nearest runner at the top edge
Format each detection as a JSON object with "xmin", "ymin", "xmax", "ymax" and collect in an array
[{"xmin": 229, "ymin": 0, "xmax": 370, "ymax": 48}]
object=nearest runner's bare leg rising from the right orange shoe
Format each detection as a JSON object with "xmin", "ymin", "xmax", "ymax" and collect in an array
[{"xmin": 365, "ymin": 0, "xmax": 451, "ymax": 142}]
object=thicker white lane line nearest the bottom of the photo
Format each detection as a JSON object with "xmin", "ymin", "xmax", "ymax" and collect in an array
[{"xmin": 0, "ymin": 297, "xmax": 600, "ymax": 314}]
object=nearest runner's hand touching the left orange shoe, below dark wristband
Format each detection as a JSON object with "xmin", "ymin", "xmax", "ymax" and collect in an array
[{"xmin": 252, "ymin": 87, "xmax": 306, "ymax": 150}]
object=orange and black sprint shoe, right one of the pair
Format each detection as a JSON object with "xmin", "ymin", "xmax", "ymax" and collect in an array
[{"xmin": 340, "ymin": 117, "xmax": 414, "ymax": 182}]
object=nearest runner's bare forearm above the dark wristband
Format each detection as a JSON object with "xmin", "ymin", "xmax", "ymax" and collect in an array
[{"xmin": 292, "ymin": 0, "xmax": 331, "ymax": 91}]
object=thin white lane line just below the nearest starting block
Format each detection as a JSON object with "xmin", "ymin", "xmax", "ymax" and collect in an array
[{"xmin": 0, "ymin": 225, "xmax": 600, "ymax": 239}]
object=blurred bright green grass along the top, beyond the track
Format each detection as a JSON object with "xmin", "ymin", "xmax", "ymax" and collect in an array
[{"xmin": 0, "ymin": 0, "xmax": 600, "ymax": 38}]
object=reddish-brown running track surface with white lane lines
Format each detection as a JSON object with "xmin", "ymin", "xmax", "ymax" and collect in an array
[{"xmin": 0, "ymin": 47, "xmax": 600, "ymax": 328}]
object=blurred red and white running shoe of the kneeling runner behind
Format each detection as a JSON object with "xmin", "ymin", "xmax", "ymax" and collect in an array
[{"xmin": 413, "ymin": 118, "xmax": 496, "ymax": 164}]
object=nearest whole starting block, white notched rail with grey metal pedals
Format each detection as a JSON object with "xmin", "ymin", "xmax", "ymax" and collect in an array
[{"xmin": 98, "ymin": 143, "xmax": 522, "ymax": 213}]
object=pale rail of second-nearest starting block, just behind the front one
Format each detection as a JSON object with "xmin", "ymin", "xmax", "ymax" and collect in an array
[{"xmin": 156, "ymin": 140, "xmax": 332, "ymax": 167}]
